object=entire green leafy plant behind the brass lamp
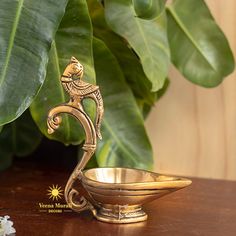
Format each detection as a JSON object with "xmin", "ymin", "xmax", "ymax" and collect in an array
[{"xmin": 0, "ymin": 0, "xmax": 234, "ymax": 169}]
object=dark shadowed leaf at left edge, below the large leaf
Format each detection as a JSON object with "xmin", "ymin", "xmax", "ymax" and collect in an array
[{"xmin": 0, "ymin": 110, "xmax": 42, "ymax": 170}]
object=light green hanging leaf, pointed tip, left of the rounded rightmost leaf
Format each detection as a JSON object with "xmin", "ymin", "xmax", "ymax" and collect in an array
[{"xmin": 105, "ymin": 0, "xmax": 169, "ymax": 91}]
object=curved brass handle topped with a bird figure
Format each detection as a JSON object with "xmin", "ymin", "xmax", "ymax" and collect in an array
[{"xmin": 47, "ymin": 57, "xmax": 104, "ymax": 214}]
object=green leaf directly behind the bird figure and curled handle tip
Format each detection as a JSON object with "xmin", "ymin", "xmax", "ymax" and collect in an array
[{"xmin": 31, "ymin": 0, "xmax": 95, "ymax": 144}]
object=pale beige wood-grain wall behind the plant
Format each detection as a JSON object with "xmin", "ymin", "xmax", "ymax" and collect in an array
[{"xmin": 146, "ymin": 0, "xmax": 236, "ymax": 180}]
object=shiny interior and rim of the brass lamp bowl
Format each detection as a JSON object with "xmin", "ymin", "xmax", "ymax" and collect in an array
[{"xmin": 82, "ymin": 167, "xmax": 191, "ymax": 190}]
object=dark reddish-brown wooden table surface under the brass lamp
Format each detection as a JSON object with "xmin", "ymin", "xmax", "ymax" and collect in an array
[{"xmin": 0, "ymin": 164, "xmax": 236, "ymax": 236}]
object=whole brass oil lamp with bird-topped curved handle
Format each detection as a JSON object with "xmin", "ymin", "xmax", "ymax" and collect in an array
[{"xmin": 47, "ymin": 57, "xmax": 191, "ymax": 223}]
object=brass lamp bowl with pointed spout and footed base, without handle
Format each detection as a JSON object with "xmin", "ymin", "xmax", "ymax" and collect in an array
[{"xmin": 81, "ymin": 168, "xmax": 191, "ymax": 223}]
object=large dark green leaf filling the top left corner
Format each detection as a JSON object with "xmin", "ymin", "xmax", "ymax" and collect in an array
[{"xmin": 0, "ymin": 0, "xmax": 67, "ymax": 125}]
